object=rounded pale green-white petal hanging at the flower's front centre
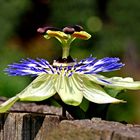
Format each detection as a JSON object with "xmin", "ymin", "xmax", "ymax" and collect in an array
[{"xmin": 55, "ymin": 74, "xmax": 83, "ymax": 106}]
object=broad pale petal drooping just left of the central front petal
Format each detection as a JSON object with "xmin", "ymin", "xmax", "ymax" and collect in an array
[{"xmin": 19, "ymin": 74, "xmax": 56, "ymax": 101}]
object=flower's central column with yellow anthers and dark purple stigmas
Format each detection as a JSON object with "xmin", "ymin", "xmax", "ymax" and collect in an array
[{"xmin": 37, "ymin": 25, "xmax": 91, "ymax": 59}]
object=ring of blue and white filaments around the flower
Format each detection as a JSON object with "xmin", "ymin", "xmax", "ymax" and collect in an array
[{"xmin": 5, "ymin": 56, "xmax": 124, "ymax": 77}]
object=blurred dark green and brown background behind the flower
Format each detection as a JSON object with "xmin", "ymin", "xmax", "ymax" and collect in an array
[{"xmin": 0, "ymin": 0, "xmax": 140, "ymax": 123}]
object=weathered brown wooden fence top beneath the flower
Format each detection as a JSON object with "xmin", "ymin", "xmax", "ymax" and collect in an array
[{"xmin": 0, "ymin": 98, "xmax": 140, "ymax": 140}]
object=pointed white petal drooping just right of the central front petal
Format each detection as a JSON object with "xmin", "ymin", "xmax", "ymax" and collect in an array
[{"xmin": 83, "ymin": 78, "xmax": 124, "ymax": 104}]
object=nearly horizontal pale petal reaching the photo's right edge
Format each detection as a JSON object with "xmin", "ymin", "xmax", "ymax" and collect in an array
[{"xmin": 84, "ymin": 74, "xmax": 140, "ymax": 90}]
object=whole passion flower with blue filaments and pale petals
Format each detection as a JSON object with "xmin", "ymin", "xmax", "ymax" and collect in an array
[{"xmin": 0, "ymin": 25, "xmax": 140, "ymax": 112}]
